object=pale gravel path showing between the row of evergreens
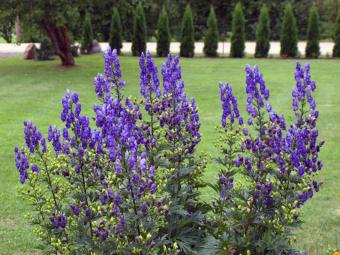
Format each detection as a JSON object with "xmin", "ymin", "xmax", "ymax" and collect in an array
[{"xmin": 0, "ymin": 42, "xmax": 334, "ymax": 57}]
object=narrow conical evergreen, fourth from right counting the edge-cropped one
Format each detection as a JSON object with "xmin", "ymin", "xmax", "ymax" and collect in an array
[{"xmin": 255, "ymin": 5, "xmax": 270, "ymax": 58}]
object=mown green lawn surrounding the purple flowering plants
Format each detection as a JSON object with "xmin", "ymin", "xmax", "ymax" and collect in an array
[{"xmin": 0, "ymin": 55, "xmax": 340, "ymax": 255}]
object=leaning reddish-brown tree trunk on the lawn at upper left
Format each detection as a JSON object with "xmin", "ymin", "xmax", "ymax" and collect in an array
[{"xmin": 43, "ymin": 17, "xmax": 74, "ymax": 66}]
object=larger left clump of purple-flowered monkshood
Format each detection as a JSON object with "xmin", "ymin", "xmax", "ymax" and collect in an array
[{"xmin": 15, "ymin": 49, "xmax": 206, "ymax": 254}]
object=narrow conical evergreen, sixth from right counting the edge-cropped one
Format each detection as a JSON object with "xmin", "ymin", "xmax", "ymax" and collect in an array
[{"xmin": 203, "ymin": 6, "xmax": 219, "ymax": 57}]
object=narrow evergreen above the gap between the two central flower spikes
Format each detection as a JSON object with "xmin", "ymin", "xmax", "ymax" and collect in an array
[{"xmin": 157, "ymin": 7, "xmax": 170, "ymax": 57}]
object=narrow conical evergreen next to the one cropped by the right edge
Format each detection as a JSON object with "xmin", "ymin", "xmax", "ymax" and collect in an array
[{"xmin": 306, "ymin": 4, "xmax": 320, "ymax": 58}]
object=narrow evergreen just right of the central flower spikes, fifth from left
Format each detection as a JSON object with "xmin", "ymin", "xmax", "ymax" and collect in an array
[{"xmin": 180, "ymin": 4, "xmax": 195, "ymax": 58}]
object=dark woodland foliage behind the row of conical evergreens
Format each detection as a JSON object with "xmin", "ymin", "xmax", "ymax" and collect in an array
[{"xmin": 0, "ymin": 0, "xmax": 340, "ymax": 41}]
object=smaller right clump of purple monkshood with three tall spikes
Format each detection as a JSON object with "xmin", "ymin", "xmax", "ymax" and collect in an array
[{"xmin": 212, "ymin": 63, "xmax": 323, "ymax": 255}]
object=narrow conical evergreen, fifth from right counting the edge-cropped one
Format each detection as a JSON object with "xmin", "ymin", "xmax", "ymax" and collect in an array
[{"xmin": 230, "ymin": 2, "xmax": 245, "ymax": 58}]
